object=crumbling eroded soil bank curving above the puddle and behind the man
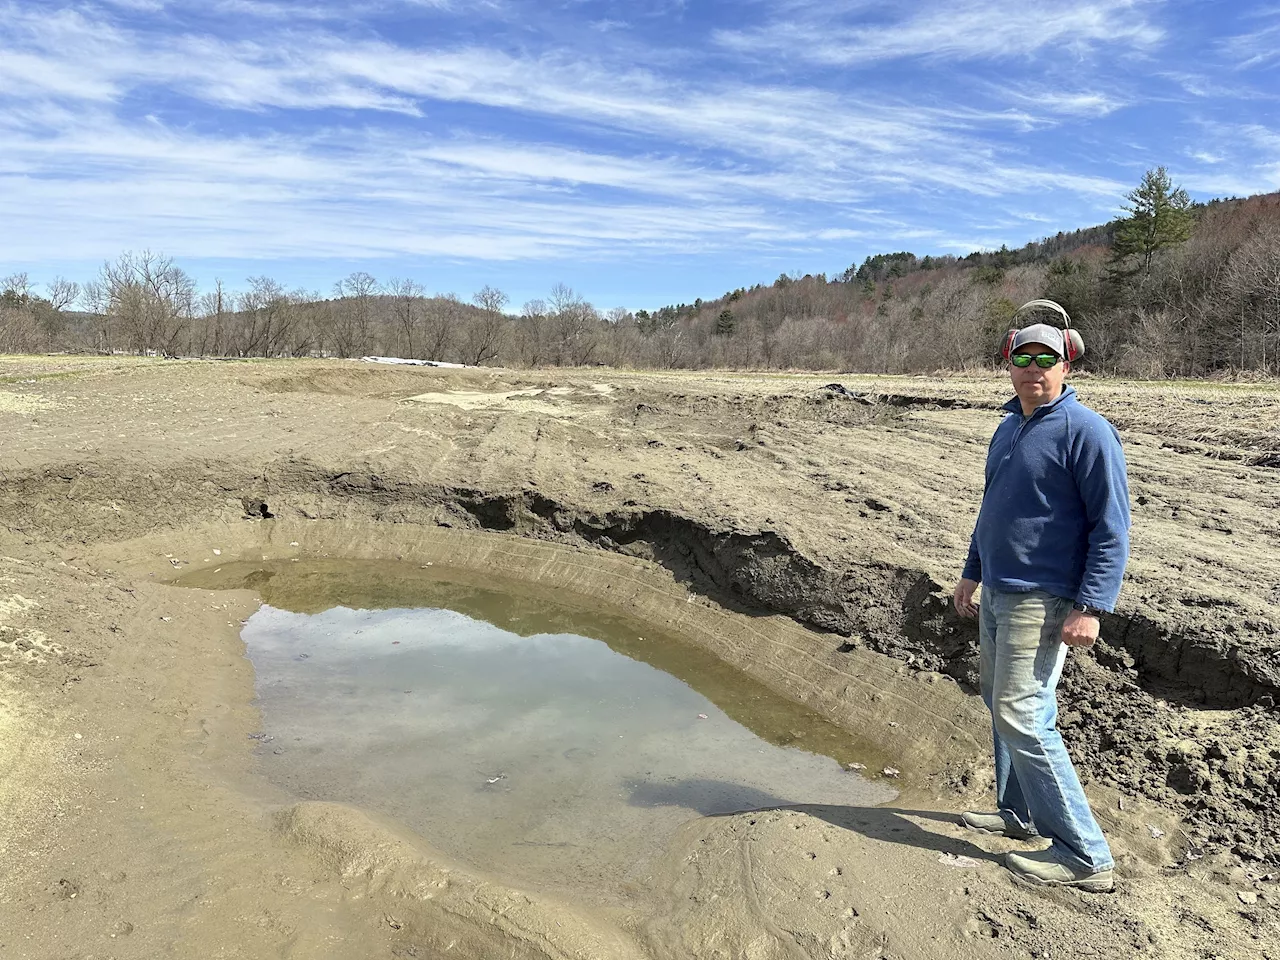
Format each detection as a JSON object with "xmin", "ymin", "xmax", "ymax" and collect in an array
[{"xmin": 5, "ymin": 460, "xmax": 1280, "ymax": 860}]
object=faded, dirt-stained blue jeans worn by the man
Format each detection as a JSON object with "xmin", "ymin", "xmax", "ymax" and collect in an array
[{"xmin": 978, "ymin": 586, "xmax": 1114, "ymax": 873}]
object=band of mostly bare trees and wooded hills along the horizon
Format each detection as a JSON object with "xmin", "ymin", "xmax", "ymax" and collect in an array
[{"xmin": 0, "ymin": 168, "xmax": 1280, "ymax": 378}]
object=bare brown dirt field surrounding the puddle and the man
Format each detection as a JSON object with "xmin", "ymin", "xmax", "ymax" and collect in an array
[{"xmin": 0, "ymin": 357, "xmax": 1280, "ymax": 960}]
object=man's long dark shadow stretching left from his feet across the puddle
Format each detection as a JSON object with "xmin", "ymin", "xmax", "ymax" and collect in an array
[{"xmin": 623, "ymin": 778, "xmax": 1002, "ymax": 863}]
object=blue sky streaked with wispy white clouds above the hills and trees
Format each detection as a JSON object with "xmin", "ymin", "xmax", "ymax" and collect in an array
[{"xmin": 0, "ymin": 0, "xmax": 1280, "ymax": 308}]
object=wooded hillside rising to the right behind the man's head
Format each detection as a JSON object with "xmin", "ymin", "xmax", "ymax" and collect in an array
[{"xmin": 636, "ymin": 179, "xmax": 1280, "ymax": 376}]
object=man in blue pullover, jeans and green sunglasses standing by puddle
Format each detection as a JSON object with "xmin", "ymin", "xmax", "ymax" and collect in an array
[{"xmin": 954, "ymin": 317, "xmax": 1129, "ymax": 892}]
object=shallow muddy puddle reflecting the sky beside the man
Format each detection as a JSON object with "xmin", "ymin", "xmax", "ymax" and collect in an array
[{"xmin": 182, "ymin": 561, "xmax": 893, "ymax": 902}]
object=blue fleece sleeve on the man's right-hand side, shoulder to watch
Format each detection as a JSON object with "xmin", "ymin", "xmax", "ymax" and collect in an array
[{"xmin": 1071, "ymin": 417, "xmax": 1129, "ymax": 612}]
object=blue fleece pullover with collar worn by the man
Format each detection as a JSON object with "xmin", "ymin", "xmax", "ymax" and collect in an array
[{"xmin": 963, "ymin": 387, "xmax": 1129, "ymax": 611}]
